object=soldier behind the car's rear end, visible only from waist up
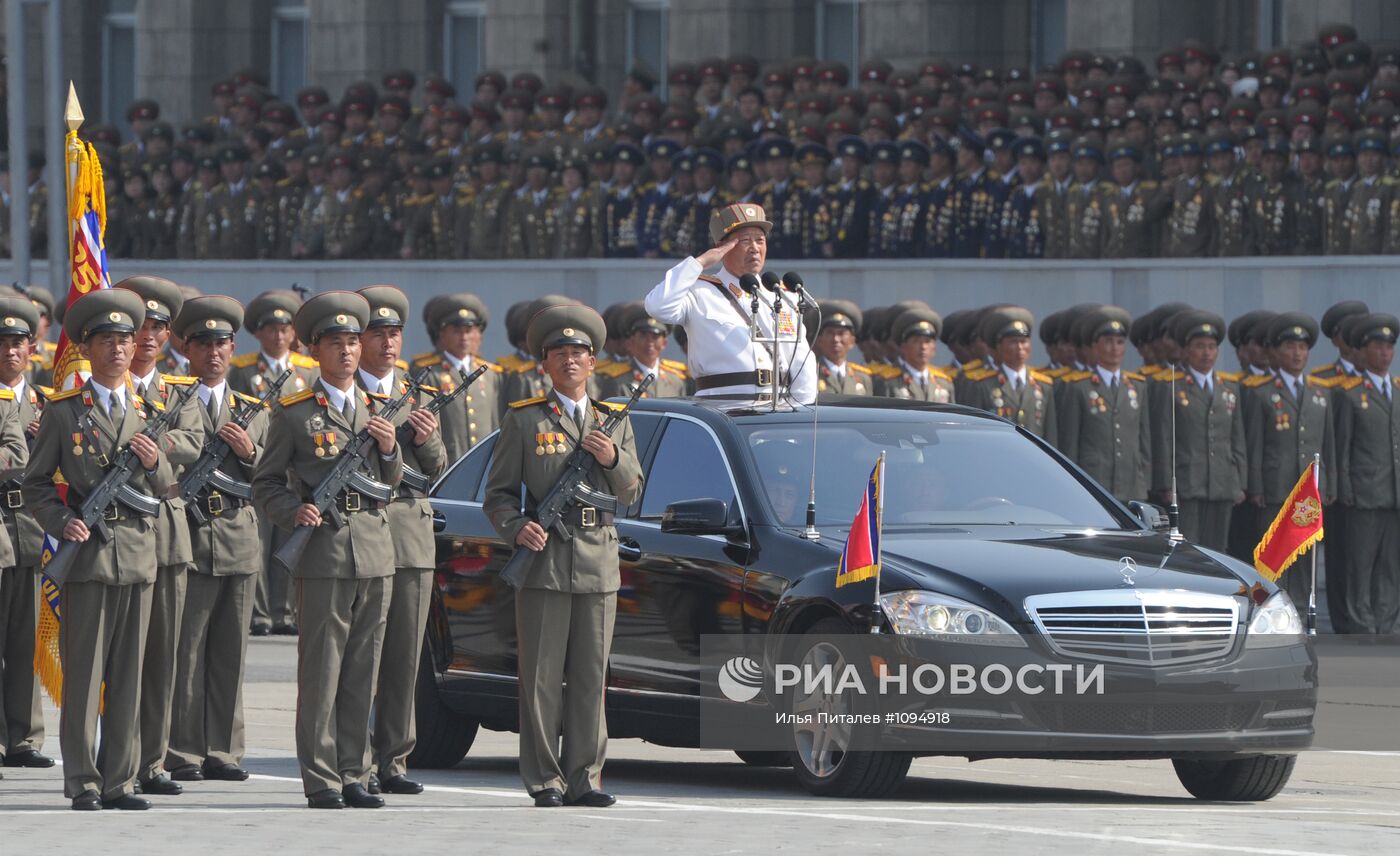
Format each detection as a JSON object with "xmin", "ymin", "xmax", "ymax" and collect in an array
[{"xmin": 413, "ymin": 293, "xmax": 503, "ymax": 464}]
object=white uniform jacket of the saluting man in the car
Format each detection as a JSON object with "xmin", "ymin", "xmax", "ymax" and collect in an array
[{"xmin": 647, "ymin": 256, "xmax": 816, "ymax": 403}]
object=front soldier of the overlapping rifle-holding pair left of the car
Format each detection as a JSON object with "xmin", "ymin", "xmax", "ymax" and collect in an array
[{"xmin": 252, "ymin": 291, "xmax": 403, "ymax": 808}]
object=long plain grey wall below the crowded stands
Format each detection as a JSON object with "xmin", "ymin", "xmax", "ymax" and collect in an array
[{"xmin": 0, "ymin": 256, "xmax": 1400, "ymax": 368}]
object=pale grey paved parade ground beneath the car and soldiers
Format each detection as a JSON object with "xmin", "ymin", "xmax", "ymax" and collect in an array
[{"xmin": 0, "ymin": 637, "xmax": 1400, "ymax": 856}]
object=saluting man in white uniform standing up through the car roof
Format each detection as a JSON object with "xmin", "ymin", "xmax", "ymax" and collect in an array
[{"xmin": 647, "ymin": 203, "xmax": 816, "ymax": 403}]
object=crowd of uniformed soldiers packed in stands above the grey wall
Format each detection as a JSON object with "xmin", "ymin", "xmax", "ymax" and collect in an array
[{"xmin": 0, "ymin": 24, "xmax": 1400, "ymax": 259}]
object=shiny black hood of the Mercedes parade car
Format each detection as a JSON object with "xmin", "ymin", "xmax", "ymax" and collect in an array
[{"xmin": 881, "ymin": 527, "xmax": 1257, "ymax": 619}]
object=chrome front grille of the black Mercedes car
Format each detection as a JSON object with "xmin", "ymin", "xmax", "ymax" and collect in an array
[{"xmin": 1026, "ymin": 588, "xmax": 1240, "ymax": 665}]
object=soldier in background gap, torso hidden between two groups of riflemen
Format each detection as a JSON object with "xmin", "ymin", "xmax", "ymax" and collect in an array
[{"xmin": 228, "ymin": 289, "xmax": 316, "ymax": 636}]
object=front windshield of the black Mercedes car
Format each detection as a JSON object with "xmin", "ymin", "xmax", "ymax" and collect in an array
[{"xmin": 745, "ymin": 413, "xmax": 1123, "ymax": 530}]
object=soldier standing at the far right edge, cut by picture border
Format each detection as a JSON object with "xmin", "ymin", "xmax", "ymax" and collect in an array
[{"xmin": 1329, "ymin": 314, "xmax": 1400, "ymax": 633}]
